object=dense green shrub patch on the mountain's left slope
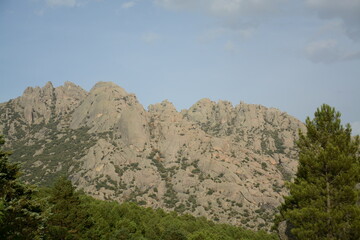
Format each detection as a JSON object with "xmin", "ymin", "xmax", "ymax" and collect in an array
[{"xmin": 9, "ymin": 123, "xmax": 96, "ymax": 186}]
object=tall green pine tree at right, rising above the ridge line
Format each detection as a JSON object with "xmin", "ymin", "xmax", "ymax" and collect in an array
[{"xmin": 280, "ymin": 104, "xmax": 360, "ymax": 240}]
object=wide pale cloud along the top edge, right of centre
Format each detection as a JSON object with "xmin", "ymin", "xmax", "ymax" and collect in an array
[{"xmin": 153, "ymin": 0, "xmax": 288, "ymax": 50}]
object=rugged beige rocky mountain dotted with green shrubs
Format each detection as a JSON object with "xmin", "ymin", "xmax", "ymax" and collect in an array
[{"xmin": 0, "ymin": 82, "xmax": 304, "ymax": 232}]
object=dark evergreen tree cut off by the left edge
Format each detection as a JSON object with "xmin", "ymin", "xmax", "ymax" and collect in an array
[{"xmin": 0, "ymin": 136, "xmax": 42, "ymax": 239}]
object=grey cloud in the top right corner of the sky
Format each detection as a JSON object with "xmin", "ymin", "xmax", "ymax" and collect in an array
[{"xmin": 305, "ymin": 0, "xmax": 360, "ymax": 41}]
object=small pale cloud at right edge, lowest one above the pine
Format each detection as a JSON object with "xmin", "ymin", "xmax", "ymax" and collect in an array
[{"xmin": 305, "ymin": 39, "xmax": 360, "ymax": 63}]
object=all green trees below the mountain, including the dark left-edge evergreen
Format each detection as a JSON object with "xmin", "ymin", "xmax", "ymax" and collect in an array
[{"xmin": 0, "ymin": 138, "xmax": 277, "ymax": 240}]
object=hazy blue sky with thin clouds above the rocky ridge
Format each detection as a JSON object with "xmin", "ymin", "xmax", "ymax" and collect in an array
[{"xmin": 0, "ymin": 0, "xmax": 360, "ymax": 134}]
